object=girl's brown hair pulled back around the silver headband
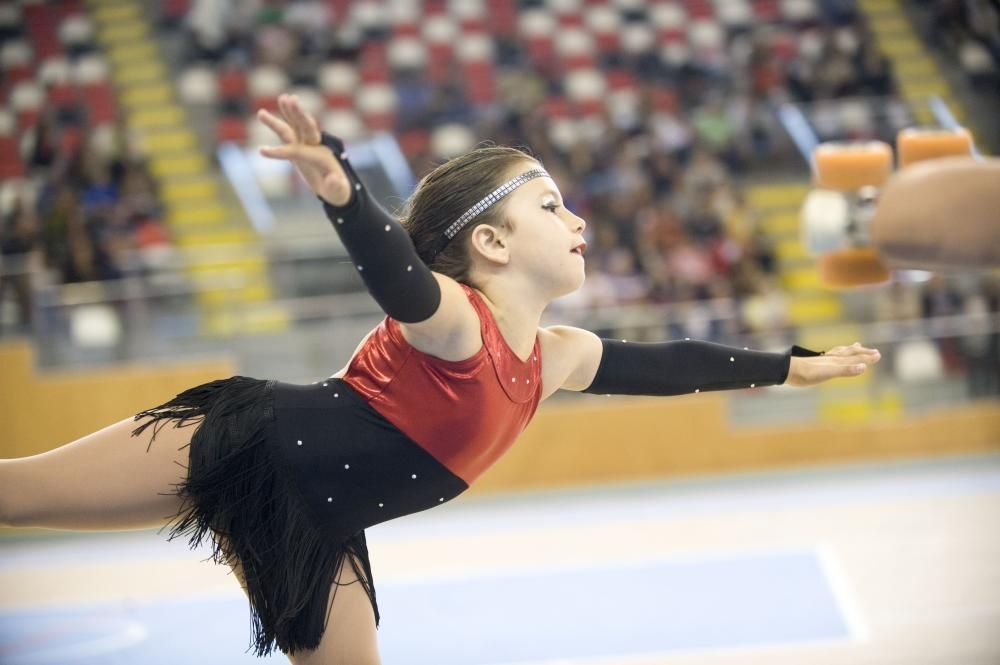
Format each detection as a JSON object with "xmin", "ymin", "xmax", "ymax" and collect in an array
[{"xmin": 400, "ymin": 146, "xmax": 538, "ymax": 284}]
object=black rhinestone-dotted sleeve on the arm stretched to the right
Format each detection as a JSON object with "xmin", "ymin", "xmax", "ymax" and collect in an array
[{"xmin": 583, "ymin": 338, "xmax": 822, "ymax": 396}]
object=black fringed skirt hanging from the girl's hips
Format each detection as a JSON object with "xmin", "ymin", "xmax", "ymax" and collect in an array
[{"xmin": 132, "ymin": 376, "xmax": 379, "ymax": 656}]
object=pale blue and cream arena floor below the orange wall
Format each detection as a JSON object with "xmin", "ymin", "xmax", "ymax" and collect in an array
[{"xmin": 0, "ymin": 455, "xmax": 1000, "ymax": 665}]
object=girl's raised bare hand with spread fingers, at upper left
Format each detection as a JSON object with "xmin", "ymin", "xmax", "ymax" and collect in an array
[{"xmin": 257, "ymin": 95, "xmax": 351, "ymax": 206}]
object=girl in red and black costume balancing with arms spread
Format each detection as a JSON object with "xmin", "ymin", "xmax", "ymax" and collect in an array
[{"xmin": 0, "ymin": 95, "xmax": 879, "ymax": 665}]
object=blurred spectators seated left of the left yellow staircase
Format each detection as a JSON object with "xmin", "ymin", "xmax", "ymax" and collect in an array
[{"xmin": 0, "ymin": 109, "xmax": 172, "ymax": 328}]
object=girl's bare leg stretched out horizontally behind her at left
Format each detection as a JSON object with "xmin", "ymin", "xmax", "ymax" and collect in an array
[{"xmin": 0, "ymin": 416, "xmax": 200, "ymax": 531}]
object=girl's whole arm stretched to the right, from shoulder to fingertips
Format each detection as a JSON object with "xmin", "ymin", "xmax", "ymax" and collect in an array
[{"xmin": 550, "ymin": 326, "xmax": 879, "ymax": 396}]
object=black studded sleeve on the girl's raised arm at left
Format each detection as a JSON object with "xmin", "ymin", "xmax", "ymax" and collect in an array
[{"xmin": 319, "ymin": 132, "xmax": 441, "ymax": 323}]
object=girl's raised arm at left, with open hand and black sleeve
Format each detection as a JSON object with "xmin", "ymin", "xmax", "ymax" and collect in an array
[{"xmin": 259, "ymin": 95, "xmax": 441, "ymax": 323}]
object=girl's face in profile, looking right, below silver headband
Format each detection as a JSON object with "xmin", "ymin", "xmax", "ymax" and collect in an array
[{"xmin": 502, "ymin": 162, "xmax": 587, "ymax": 298}]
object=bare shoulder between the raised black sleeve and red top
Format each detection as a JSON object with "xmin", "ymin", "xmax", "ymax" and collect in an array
[{"xmin": 399, "ymin": 272, "xmax": 482, "ymax": 360}]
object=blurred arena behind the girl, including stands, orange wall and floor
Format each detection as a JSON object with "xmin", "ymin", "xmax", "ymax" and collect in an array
[{"xmin": 0, "ymin": 0, "xmax": 1000, "ymax": 665}]
